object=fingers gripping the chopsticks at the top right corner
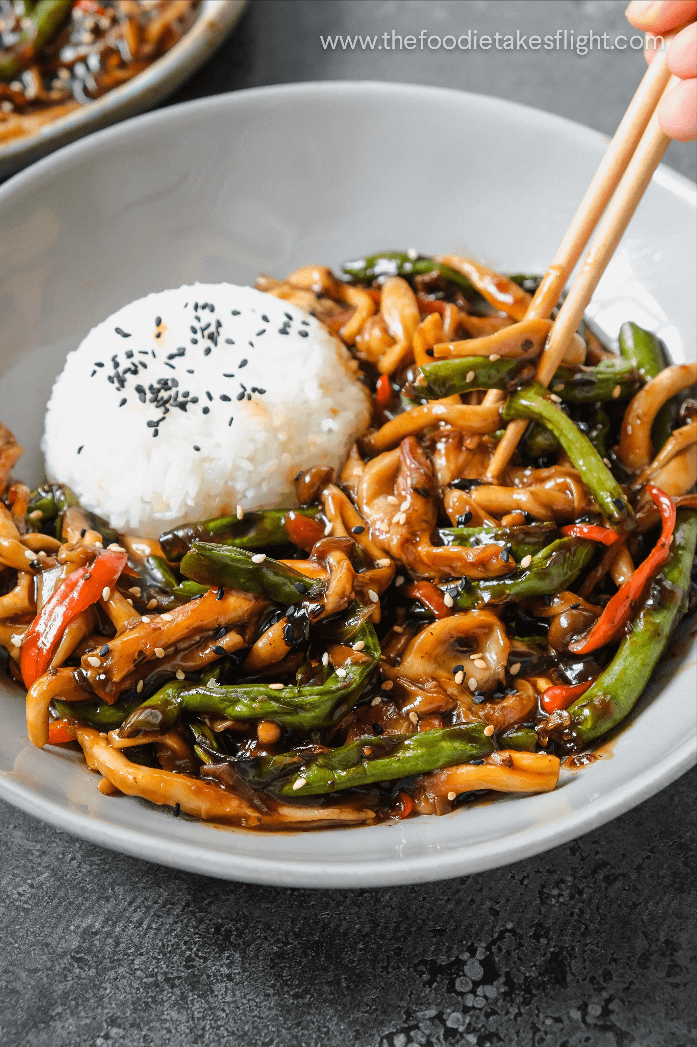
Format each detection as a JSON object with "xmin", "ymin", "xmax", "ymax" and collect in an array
[{"xmin": 626, "ymin": 0, "xmax": 697, "ymax": 141}]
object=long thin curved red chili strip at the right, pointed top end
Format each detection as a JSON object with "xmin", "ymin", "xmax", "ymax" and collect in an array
[{"xmin": 568, "ymin": 484, "xmax": 675, "ymax": 654}]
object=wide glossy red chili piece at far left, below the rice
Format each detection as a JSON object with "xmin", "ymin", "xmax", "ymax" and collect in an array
[{"xmin": 20, "ymin": 552, "xmax": 127, "ymax": 687}]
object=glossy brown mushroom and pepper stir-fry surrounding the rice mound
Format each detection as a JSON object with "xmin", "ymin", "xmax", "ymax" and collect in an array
[{"xmin": 0, "ymin": 250, "xmax": 697, "ymax": 829}]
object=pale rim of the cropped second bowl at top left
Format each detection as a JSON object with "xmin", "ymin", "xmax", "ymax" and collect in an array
[{"xmin": 0, "ymin": 0, "xmax": 246, "ymax": 178}]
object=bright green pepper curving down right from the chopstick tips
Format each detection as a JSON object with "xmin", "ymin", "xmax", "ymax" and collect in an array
[{"xmin": 503, "ymin": 384, "xmax": 631, "ymax": 524}]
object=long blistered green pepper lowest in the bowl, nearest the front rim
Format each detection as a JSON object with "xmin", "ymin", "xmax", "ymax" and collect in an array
[{"xmin": 242, "ymin": 723, "xmax": 494, "ymax": 797}]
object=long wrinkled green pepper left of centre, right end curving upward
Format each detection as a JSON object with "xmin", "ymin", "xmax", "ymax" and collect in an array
[{"xmin": 122, "ymin": 622, "xmax": 380, "ymax": 735}]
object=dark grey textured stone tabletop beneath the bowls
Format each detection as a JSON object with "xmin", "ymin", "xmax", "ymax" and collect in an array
[{"xmin": 0, "ymin": 0, "xmax": 697, "ymax": 1047}]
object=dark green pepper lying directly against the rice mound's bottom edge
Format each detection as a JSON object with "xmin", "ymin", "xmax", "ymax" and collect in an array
[{"xmin": 160, "ymin": 507, "xmax": 320, "ymax": 563}]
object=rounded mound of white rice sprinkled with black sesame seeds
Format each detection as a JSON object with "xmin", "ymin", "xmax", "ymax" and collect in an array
[{"xmin": 42, "ymin": 284, "xmax": 369, "ymax": 537}]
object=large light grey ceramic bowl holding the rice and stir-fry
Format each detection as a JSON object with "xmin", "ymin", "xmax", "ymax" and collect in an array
[{"xmin": 0, "ymin": 83, "xmax": 696, "ymax": 887}]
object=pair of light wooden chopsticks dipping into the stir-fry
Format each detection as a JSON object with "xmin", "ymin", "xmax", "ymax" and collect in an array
[{"xmin": 485, "ymin": 51, "xmax": 677, "ymax": 481}]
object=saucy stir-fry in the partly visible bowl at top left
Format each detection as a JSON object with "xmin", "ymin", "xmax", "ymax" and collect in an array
[{"xmin": 0, "ymin": 0, "xmax": 199, "ymax": 143}]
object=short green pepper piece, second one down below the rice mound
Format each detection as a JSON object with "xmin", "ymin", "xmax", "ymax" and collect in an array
[{"xmin": 180, "ymin": 541, "xmax": 324, "ymax": 604}]
